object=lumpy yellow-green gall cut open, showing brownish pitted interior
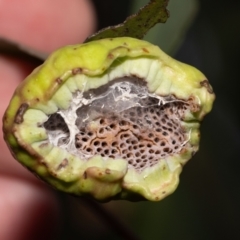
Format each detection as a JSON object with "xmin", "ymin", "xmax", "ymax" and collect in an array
[{"xmin": 3, "ymin": 37, "xmax": 215, "ymax": 201}]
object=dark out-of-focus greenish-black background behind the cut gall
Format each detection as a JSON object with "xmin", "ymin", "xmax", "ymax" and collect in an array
[{"xmin": 57, "ymin": 0, "xmax": 240, "ymax": 240}]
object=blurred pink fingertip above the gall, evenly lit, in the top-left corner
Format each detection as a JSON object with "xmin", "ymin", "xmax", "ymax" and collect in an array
[{"xmin": 0, "ymin": 0, "xmax": 96, "ymax": 52}]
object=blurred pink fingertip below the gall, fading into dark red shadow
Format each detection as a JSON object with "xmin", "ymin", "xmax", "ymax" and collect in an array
[{"xmin": 0, "ymin": 175, "xmax": 60, "ymax": 240}]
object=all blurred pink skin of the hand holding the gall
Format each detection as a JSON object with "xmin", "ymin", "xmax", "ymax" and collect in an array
[{"xmin": 0, "ymin": 0, "xmax": 95, "ymax": 240}]
